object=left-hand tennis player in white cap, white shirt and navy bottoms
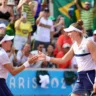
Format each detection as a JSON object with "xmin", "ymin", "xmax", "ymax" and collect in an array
[{"xmin": 0, "ymin": 35, "xmax": 38, "ymax": 96}]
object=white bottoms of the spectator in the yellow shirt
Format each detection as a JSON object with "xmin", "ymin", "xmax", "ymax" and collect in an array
[{"xmin": 13, "ymin": 35, "xmax": 28, "ymax": 50}]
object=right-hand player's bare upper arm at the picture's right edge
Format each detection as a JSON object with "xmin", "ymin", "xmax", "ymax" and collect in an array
[{"xmin": 87, "ymin": 40, "xmax": 96, "ymax": 61}]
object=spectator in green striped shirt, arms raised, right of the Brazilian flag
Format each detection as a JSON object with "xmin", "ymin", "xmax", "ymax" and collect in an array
[{"xmin": 75, "ymin": 0, "xmax": 96, "ymax": 36}]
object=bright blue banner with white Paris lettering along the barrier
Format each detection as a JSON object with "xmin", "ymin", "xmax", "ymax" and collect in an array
[{"xmin": 7, "ymin": 70, "xmax": 73, "ymax": 96}]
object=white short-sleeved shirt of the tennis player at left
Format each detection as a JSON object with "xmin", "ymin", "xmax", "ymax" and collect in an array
[{"xmin": 0, "ymin": 48, "xmax": 11, "ymax": 79}]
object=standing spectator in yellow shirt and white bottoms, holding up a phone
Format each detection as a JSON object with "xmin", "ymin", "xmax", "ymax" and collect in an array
[{"xmin": 14, "ymin": 12, "xmax": 32, "ymax": 51}]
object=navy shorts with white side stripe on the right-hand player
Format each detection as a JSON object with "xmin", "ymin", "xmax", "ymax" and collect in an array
[{"xmin": 72, "ymin": 70, "xmax": 95, "ymax": 95}]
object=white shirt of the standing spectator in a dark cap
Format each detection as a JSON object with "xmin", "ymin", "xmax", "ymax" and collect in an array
[{"xmin": 36, "ymin": 17, "xmax": 54, "ymax": 42}]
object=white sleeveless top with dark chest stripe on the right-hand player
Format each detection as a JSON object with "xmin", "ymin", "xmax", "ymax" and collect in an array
[{"xmin": 72, "ymin": 38, "xmax": 96, "ymax": 72}]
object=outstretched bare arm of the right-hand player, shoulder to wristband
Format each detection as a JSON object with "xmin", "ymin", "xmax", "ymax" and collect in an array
[{"xmin": 50, "ymin": 47, "xmax": 74, "ymax": 64}]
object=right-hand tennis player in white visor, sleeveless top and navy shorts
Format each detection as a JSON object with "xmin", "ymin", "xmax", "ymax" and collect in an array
[{"xmin": 38, "ymin": 20, "xmax": 96, "ymax": 96}]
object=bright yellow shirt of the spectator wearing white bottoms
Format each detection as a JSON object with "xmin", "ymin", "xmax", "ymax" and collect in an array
[{"xmin": 15, "ymin": 20, "xmax": 32, "ymax": 37}]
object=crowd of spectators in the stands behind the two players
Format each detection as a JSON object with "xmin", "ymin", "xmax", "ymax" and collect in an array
[{"xmin": 0, "ymin": 0, "xmax": 96, "ymax": 69}]
